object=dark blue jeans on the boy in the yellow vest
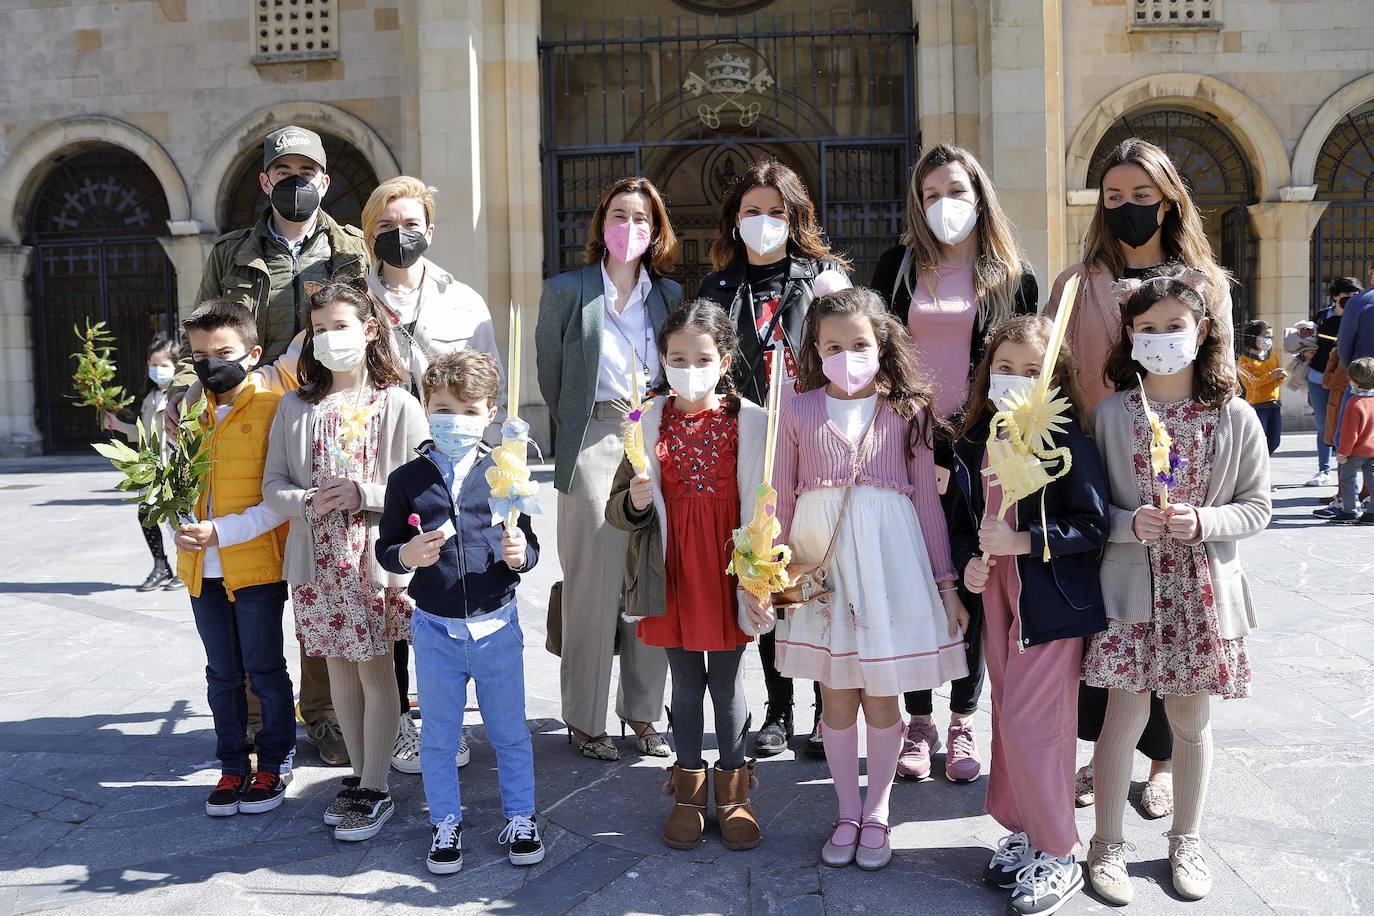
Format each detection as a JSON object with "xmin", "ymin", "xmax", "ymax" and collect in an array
[{"xmin": 191, "ymin": 578, "xmax": 295, "ymax": 777}]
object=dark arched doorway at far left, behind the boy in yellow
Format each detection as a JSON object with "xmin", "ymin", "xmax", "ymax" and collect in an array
[{"xmin": 25, "ymin": 146, "xmax": 176, "ymax": 453}]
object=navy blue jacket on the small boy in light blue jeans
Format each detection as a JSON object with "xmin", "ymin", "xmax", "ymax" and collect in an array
[{"xmin": 375, "ymin": 442, "xmax": 539, "ymax": 617}]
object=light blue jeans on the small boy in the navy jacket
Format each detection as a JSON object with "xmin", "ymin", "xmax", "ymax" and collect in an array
[{"xmin": 411, "ymin": 602, "xmax": 534, "ymax": 824}]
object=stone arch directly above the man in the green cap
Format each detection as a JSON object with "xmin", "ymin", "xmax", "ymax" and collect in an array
[{"xmin": 191, "ymin": 102, "xmax": 401, "ymax": 231}]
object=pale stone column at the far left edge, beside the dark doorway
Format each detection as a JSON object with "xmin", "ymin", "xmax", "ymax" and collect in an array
[{"xmin": 0, "ymin": 244, "xmax": 43, "ymax": 457}]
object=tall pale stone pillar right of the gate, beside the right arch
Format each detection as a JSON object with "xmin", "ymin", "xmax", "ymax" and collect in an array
[{"xmin": 978, "ymin": 0, "xmax": 1077, "ymax": 295}]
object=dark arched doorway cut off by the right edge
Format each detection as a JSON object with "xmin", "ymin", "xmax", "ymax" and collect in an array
[{"xmin": 1312, "ymin": 100, "xmax": 1374, "ymax": 308}]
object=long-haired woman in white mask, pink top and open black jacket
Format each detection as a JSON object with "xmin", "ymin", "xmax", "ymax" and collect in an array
[{"xmin": 871, "ymin": 146, "xmax": 1040, "ymax": 783}]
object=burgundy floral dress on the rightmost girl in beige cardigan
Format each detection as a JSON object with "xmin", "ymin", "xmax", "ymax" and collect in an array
[{"xmin": 1083, "ymin": 390, "xmax": 1250, "ymax": 698}]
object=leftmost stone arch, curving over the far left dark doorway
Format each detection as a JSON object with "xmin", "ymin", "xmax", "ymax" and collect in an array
[{"xmin": 0, "ymin": 114, "xmax": 191, "ymax": 243}]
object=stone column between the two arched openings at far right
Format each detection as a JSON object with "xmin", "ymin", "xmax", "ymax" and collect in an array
[{"xmin": 1237, "ymin": 185, "xmax": 1327, "ymax": 430}]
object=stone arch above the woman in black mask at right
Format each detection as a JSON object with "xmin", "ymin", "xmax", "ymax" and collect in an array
[{"xmin": 1065, "ymin": 73, "xmax": 1292, "ymax": 201}]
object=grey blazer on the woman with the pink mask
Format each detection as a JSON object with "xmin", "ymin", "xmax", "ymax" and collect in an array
[{"xmin": 534, "ymin": 264, "xmax": 683, "ymax": 493}]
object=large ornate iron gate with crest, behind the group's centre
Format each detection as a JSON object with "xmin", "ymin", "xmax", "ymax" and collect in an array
[{"xmin": 539, "ymin": 0, "xmax": 919, "ymax": 289}]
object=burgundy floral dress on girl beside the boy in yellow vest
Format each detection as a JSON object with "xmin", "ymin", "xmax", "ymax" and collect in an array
[{"xmin": 291, "ymin": 387, "xmax": 411, "ymax": 662}]
